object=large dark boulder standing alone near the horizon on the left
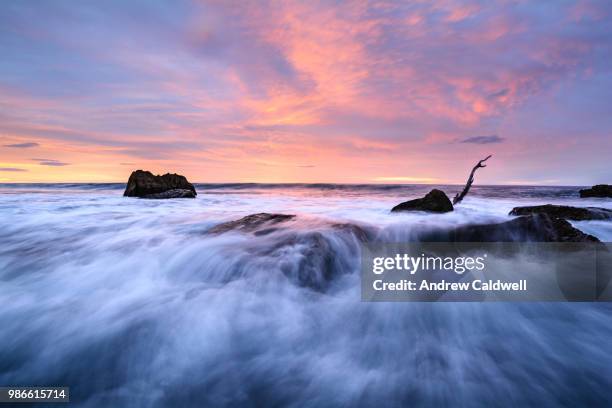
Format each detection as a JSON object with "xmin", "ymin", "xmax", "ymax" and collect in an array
[{"xmin": 123, "ymin": 170, "xmax": 197, "ymax": 198}]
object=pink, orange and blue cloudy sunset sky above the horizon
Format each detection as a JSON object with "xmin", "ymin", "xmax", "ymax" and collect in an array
[{"xmin": 0, "ymin": 0, "xmax": 612, "ymax": 185}]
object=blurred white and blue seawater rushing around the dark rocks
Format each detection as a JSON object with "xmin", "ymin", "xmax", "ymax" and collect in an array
[{"xmin": 0, "ymin": 184, "xmax": 612, "ymax": 407}]
